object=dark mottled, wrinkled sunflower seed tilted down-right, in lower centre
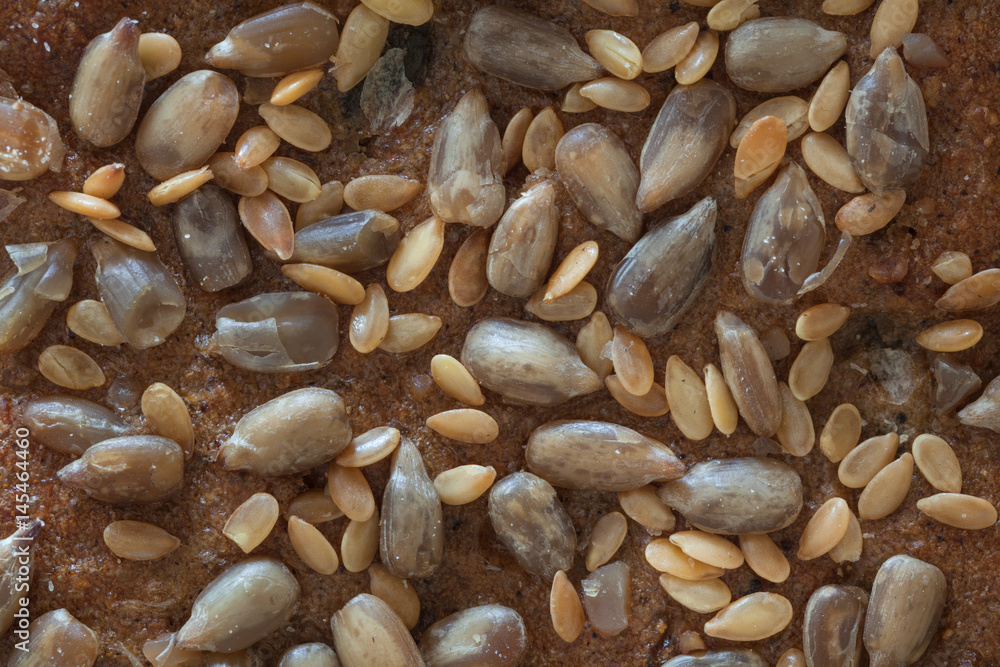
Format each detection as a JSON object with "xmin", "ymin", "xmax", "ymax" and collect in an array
[{"xmin": 488, "ymin": 472, "xmax": 576, "ymax": 580}]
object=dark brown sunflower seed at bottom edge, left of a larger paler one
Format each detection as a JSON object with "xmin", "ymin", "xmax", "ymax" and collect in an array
[{"xmin": 802, "ymin": 586, "xmax": 868, "ymax": 667}]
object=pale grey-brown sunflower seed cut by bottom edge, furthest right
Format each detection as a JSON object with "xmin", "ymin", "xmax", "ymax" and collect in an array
[{"xmin": 864, "ymin": 556, "xmax": 948, "ymax": 665}]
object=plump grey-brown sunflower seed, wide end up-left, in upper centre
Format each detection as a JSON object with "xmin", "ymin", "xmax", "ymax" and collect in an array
[{"xmin": 555, "ymin": 123, "xmax": 642, "ymax": 242}]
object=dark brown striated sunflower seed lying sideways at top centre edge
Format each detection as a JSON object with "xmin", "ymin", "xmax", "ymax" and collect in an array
[{"xmin": 465, "ymin": 5, "xmax": 601, "ymax": 90}]
